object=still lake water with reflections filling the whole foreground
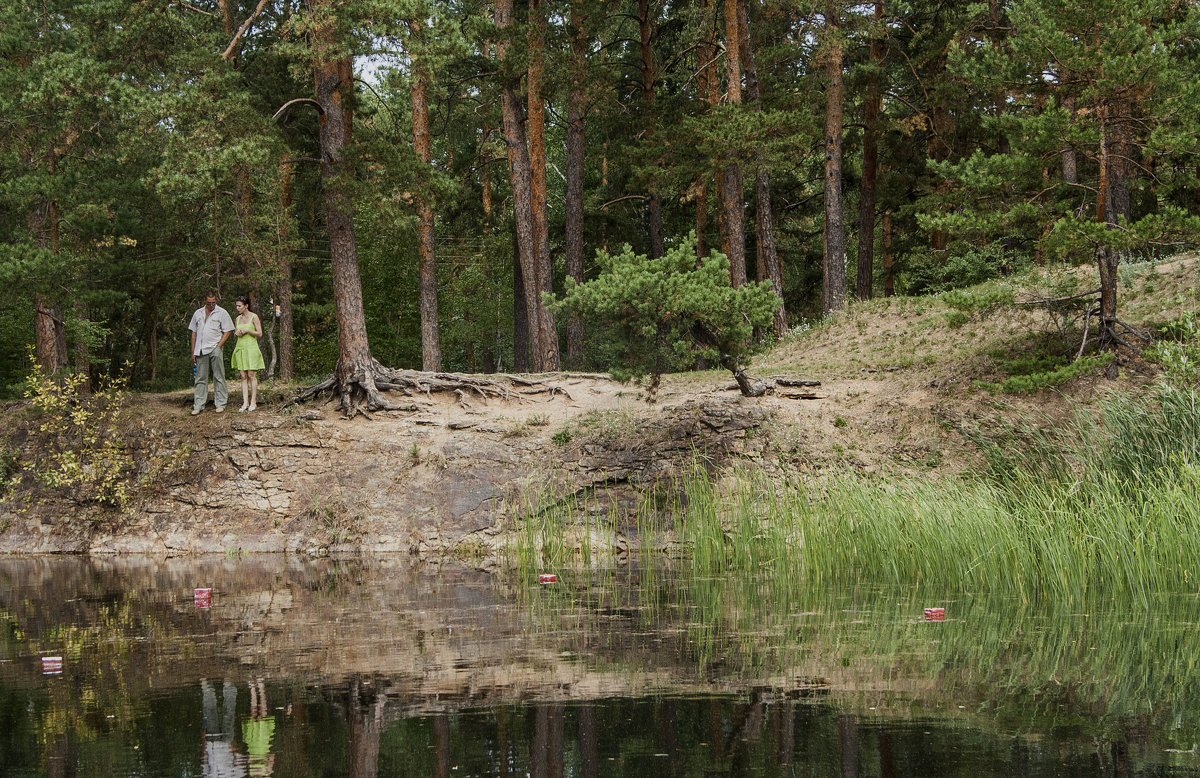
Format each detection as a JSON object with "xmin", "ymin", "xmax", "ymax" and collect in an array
[{"xmin": 0, "ymin": 556, "xmax": 1200, "ymax": 778}]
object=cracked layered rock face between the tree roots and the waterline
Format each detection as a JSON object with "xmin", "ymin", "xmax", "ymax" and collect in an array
[{"xmin": 0, "ymin": 388, "xmax": 770, "ymax": 558}]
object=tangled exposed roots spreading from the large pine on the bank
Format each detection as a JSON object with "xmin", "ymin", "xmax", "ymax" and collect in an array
[{"xmin": 283, "ymin": 359, "xmax": 571, "ymax": 418}]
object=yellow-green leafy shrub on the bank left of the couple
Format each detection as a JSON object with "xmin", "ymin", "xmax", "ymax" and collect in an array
[{"xmin": 24, "ymin": 357, "xmax": 133, "ymax": 510}]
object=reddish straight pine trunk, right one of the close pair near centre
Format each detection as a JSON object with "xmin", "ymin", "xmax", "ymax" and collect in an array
[{"xmin": 527, "ymin": 0, "xmax": 559, "ymax": 372}]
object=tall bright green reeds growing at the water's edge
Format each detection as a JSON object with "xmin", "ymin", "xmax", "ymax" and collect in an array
[{"xmin": 676, "ymin": 387, "xmax": 1200, "ymax": 598}]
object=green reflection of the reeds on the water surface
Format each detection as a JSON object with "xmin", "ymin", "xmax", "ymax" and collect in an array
[{"xmin": 691, "ymin": 579, "xmax": 1200, "ymax": 748}]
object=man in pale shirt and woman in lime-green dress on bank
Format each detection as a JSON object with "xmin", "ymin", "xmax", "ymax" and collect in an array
[{"xmin": 187, "ymin": 292, "xmax": 266, "ymax": 415}]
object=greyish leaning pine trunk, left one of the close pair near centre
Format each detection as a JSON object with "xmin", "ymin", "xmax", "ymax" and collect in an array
[{"xmin": 496, "ymin": 0, "xmax": 544, "ymax": 371}]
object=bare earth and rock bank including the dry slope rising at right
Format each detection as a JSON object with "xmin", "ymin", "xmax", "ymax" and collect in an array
[{"xmin": 7, "ymin": 253, "xmax": 1198, "ymax": 559}]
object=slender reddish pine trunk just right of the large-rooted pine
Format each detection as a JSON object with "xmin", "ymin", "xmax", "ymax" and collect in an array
[{"xmin": 408, "ymin": 19, "xmax": 442, "ymax": 372}]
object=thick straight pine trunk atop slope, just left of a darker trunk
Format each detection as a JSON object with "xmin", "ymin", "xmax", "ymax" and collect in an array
[{"xmin": 821, "ymin": 2, "xmax": 846, "ymax": 313}]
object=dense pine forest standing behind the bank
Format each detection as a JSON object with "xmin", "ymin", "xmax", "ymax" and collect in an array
[{"xmin": 0, "ymin": 0, "xmax": 1200, "ymax": 398}]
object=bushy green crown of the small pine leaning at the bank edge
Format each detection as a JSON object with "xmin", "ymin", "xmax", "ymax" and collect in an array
[{"xmin": 546, "ymin": 235, "xmax": 779, "ymax": 373}]
